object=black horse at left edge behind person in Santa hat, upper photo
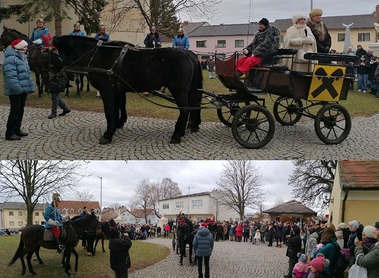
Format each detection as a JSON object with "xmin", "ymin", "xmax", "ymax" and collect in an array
[{"xmin": 0, "ymin": 26, "xmax": 43, "ymax": 97}]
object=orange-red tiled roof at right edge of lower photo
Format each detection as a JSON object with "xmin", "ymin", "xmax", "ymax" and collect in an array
[{"xmin": 339, "ymin": 160, "xmax": 379, "ymax": 190}]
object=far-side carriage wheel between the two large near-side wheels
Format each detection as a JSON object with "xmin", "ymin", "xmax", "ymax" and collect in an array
[{"xmin": 273, "ymin": 97, "xmax": 303, "ymax": 125}]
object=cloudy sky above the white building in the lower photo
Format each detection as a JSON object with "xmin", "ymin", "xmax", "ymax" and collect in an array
[{"xmin": 75, "ymin": 160, "xmax": 294, "ymax": 212}]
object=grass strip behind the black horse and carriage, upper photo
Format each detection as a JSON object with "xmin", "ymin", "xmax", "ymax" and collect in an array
[{"xmin": 0, "ymin": 71, "xmax": 379, "ymax": 121}]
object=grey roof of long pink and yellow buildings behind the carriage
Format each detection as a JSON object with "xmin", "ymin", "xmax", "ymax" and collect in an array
[{"xmin": 185, "ymin": 13, "xmax": 376, "ymax": 37}]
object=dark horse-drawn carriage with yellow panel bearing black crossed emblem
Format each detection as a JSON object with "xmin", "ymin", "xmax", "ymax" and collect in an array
[{"xmin": 201, "ymin": 49, "xmax": 357, "ymax": 149}]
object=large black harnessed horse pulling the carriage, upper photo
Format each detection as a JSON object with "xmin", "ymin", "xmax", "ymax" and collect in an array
[{"xmin": 53, "ymin": 36, "xmax": 203, "ymax": 144}]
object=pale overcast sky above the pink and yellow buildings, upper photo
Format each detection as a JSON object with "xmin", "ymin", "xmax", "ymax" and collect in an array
[{"xmin": 180, "ymin": 0, "xmax": 379, "ymax": 25}]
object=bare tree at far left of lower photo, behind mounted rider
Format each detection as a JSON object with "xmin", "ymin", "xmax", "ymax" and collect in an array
[{"xmin": 0, "ymin": 160, "xmax": 84, "ymax": 225}]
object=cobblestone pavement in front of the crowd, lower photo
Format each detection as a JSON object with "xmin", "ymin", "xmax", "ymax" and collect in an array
[{"xmin": 129, "ymin": 238, "xmax": 288, "ymax": 278}]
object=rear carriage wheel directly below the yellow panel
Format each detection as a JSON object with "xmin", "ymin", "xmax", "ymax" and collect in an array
[{"xmin": 315, "ymin": 103, "xmax": 351, "ymax": 144}]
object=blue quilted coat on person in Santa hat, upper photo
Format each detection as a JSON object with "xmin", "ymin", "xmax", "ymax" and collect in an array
[{"xmin": 3, "ymin": 48, "xmax": 34, "ymax": 96}]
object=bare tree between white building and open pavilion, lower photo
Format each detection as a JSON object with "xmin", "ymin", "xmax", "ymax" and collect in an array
[{"xmin": 217, "ymin": 160, "xmax": 265, "ymax": 220}]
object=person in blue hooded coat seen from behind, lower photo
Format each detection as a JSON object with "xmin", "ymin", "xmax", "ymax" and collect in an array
[{"xmin": 193, "ymin": 222, "xmax": 214, "ymax": 278}]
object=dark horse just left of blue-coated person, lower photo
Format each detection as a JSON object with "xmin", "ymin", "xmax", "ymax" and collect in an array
[{"xmin": 176, "ymin": 216, "xmax": 196, "ymax": 265}]
